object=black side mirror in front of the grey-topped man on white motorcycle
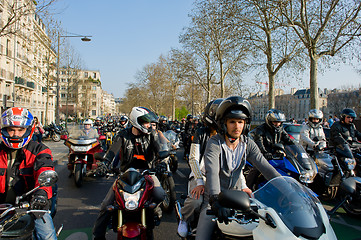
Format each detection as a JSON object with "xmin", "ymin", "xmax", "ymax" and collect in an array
[{"xmin": 218, "ymin": 190, "xmax": 251, "ymax": 211}]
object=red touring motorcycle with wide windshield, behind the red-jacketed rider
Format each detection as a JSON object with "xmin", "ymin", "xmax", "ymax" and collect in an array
[{"xmin": 64, "ymin": 126, "xmax": 108, "ymax": 187}]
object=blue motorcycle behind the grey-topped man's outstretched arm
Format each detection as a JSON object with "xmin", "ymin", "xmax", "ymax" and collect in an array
[{"xmin": 244, "ymin": 143, "xmax": 318, "ymax": 190}]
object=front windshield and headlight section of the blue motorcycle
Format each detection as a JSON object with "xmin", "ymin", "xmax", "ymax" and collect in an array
[{"xmin": 285, "ymin": 144, "xmax": 317, "ymax": 179}]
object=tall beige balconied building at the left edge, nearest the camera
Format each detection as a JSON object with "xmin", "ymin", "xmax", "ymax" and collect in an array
[{"xmin": 0, "ymin": 0, "xmax": 56, "ymax": 123}]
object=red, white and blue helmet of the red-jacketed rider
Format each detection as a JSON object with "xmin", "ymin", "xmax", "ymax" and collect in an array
[{"xmin": 0, "ymin": 107, "xmax": 35, "ymax": 149}]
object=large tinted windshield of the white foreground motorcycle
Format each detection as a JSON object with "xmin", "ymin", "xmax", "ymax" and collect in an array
[{"xmin": 253, "ymin": 176, "xmax": 326, "ymax": 239}]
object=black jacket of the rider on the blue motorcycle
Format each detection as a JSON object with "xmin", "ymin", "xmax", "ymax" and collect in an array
[{"xmin": 249, "ymin": 123, "xmax": 295, "ymax": 155}]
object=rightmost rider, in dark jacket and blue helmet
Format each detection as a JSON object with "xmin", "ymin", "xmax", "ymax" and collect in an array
[{"xmin": 330, "ymin": 108, "xmax": 361, "ymax": 147}]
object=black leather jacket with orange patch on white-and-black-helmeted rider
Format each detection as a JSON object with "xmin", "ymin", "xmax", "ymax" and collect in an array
[{"xmin": 105, "ymin": 128, "xmax": 159, "ymax": 172}]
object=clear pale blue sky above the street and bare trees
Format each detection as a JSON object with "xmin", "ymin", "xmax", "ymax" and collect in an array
[{"xmin": 55, "ymin": 0, "xmax": 361, "ymax": 97}]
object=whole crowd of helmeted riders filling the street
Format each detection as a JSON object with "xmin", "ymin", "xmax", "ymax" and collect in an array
[{"xmin": 0, "ymin": 96, "xmax": 361, "ymax": 239}]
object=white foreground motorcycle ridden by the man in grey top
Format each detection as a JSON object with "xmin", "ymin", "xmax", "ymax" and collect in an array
[{"xmin": 201, "ymin": 176, "xmax": 337, "ymax": 240}]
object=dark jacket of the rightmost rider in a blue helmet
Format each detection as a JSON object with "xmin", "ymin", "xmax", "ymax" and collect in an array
[{"xmin": 330, "ymin": 121, "xmax": 361, "ymax": 146}]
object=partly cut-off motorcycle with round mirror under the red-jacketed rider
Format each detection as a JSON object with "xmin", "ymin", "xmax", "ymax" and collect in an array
[{"xmin": 0, "ymin": 170, "xmax": 62, "ymax": 239}]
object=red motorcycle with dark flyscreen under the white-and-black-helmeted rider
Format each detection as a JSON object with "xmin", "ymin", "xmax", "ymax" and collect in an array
[{"xmin": 109, "ymin": 168, "xmax": 156, "ymax": 239}]
